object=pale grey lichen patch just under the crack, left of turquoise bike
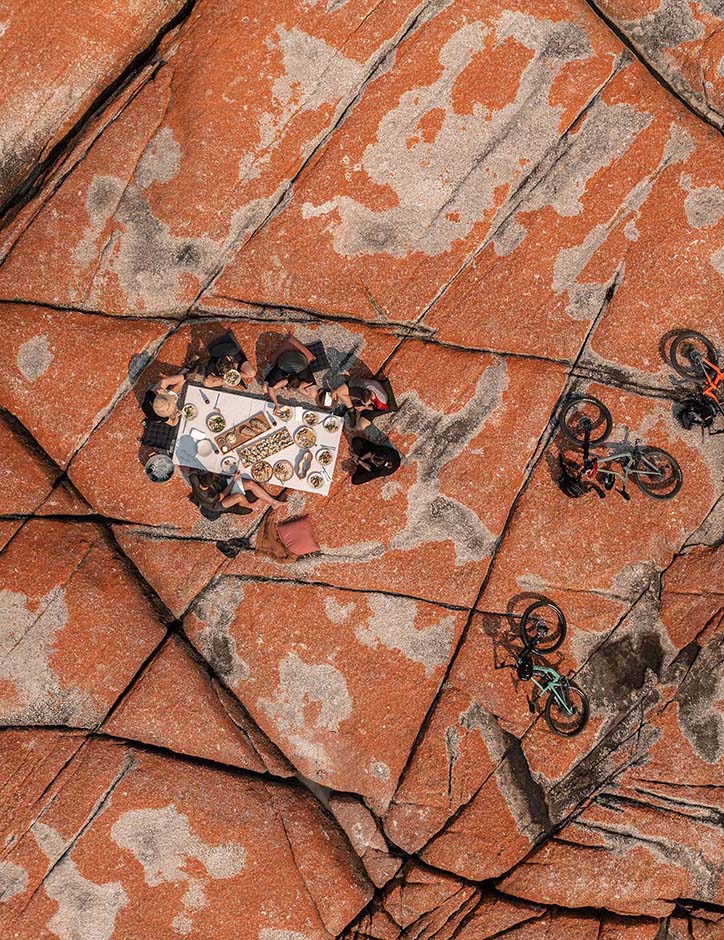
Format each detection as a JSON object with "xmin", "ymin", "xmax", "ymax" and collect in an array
[{"xmin": 355, "ymin": 594, "xmax": 455, "ymax": 677}]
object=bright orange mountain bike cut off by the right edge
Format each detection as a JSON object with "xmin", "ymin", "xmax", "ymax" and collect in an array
[{"xmin": 669, "ymin": 330, "xmax": 724, "ymax": 434}]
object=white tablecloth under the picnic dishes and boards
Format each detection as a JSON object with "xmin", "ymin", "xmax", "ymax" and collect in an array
[{"xmin": 173, "ymin": 383, "xmax": 342, "ymax": 496}]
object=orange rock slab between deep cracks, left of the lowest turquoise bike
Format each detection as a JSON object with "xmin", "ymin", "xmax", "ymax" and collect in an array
[{"xmin": 184, "ymin": 576, "xmax": 463, "ymax": 808}]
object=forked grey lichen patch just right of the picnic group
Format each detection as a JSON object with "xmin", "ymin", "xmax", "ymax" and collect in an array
[{"xmin": 392, "ymin": 359, "xmax": 509, "ymax": 565}]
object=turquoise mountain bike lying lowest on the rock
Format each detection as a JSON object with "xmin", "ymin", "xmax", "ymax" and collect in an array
[{"xmin": 515, "ymin": 601, "xmax": 590, "ymax": 738}]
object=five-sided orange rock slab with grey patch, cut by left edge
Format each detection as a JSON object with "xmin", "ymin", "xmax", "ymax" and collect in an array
[{"xmin": 0, "ymin": 519, "xmax": 164, "ymax": 728}]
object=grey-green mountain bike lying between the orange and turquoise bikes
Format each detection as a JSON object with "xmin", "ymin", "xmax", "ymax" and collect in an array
[{"xmin": 558, "ymin": 396, "xmax": 683, "ymax": 500}]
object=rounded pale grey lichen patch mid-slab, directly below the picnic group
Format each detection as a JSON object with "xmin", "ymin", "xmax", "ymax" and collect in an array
[{"xmin": 259, "ymin": 652, "xmax": 352, "ymax": 737}]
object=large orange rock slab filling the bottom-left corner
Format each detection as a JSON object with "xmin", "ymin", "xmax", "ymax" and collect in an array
[{"xmin": 0, "ymin": 732, "xmax": 371, "ymax": 940}]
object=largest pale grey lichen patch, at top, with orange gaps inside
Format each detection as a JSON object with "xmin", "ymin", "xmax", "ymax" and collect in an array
[{"xmin": 302, "ymin": 11, "xmax": 591, "ymax": 258}]
